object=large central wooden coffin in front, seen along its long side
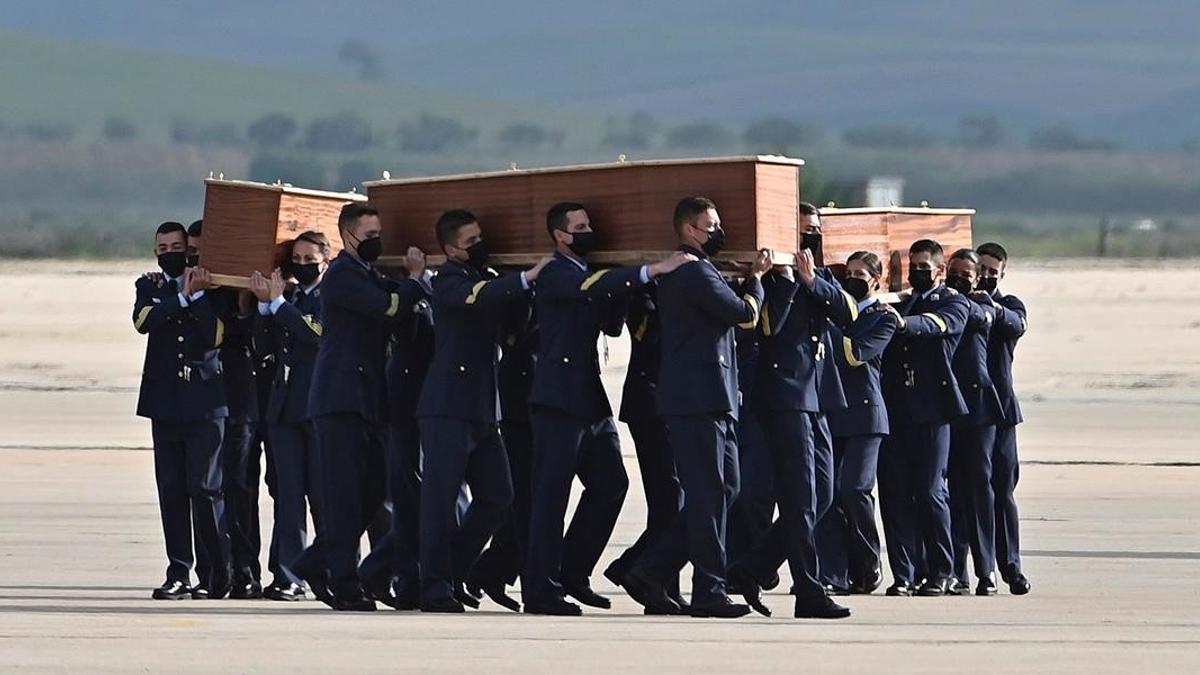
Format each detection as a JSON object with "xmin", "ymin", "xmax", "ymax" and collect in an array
[{"xmin": 365, "ymin": 156, "xmax": 804, "ymax": 264}]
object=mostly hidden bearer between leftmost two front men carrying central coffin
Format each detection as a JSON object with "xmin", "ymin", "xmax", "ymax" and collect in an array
[{"xmin": 359, "ymin": 260, "xmax": 433, "ymax": 610}]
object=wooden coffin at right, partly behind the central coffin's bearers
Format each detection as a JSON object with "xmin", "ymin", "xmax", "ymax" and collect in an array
[{"xmin": 821, "ymin": 207, "xmax": 974, "ymax": 291}]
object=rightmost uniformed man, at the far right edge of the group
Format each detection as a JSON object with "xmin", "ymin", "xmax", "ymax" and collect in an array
[{"xmin": 976, "ymin": 241, "xmax": 1031, "ymax": 596}]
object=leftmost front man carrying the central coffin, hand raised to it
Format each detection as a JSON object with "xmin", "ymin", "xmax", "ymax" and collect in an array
[{"xmin": 293, "ymin": 203, "xmax": 425, "ymax": 611}]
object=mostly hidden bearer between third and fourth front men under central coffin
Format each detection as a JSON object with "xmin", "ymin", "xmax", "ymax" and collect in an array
[{"xmin": 604, "ymin": 281, "xmax": 686, "ymax": 609}]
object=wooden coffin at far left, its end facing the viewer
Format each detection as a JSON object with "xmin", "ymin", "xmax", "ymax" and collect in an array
[{"xmin": 200, "ymin": 178, "xmax": 367, "ymax": 287}]
